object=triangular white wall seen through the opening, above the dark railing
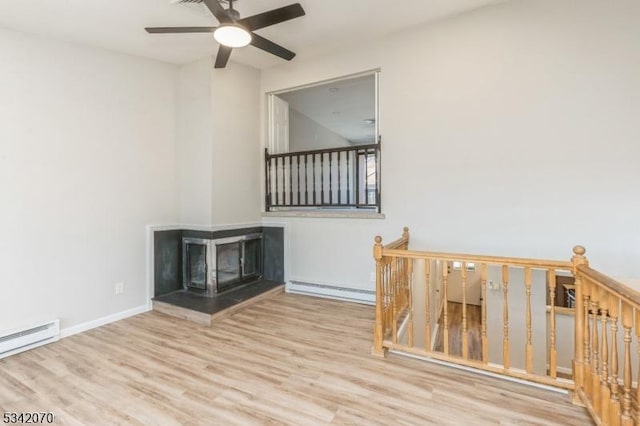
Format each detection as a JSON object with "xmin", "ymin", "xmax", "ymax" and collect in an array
[{"xmin": 289, "ymin": 108, "xmax": 351, "ymax": 151}]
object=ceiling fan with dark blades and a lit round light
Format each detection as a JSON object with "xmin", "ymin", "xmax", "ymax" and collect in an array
[{"xmin": 145, "ymin": 0, "xmax": 305, "ymax": 68}]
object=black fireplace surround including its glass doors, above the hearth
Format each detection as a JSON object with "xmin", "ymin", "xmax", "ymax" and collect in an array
[{"xmin": 154, "ymin": 226, "xmax": 284, "ymax": 297}]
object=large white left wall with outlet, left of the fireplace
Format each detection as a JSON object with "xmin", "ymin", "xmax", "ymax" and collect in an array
[{"xmin": 0, "ymin": 30, "xmax": 178, "ymax": 329}]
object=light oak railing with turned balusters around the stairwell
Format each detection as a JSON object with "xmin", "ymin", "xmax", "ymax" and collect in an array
[{"xmin": 372, "ymin": 228, "xmax": 640, "ymax": 425}]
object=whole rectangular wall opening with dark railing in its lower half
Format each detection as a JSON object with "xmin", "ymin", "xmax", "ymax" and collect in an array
[{"xmin": 265, "ymin": 71, "xmax": 381, "ymax": 216}]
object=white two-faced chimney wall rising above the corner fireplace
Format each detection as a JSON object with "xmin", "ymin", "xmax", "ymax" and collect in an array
[{"xmin": 177, "ymin": 58, "xmax": 263, "ymax": 226}]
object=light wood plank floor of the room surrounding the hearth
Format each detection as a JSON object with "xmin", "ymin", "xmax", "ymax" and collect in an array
[{"xmin": 0, "ymin": 294, "xmax": 591, "ymax": 425}]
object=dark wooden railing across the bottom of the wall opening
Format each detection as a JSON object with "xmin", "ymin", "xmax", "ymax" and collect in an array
[{"xmin": 264, "ymin": 143, "xmax": 380, "ymax": 212}]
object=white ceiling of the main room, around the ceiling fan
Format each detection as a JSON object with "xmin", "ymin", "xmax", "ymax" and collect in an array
[{"xmin": 0, "ymin": 0, "xmax": 504, "ymax": 68}]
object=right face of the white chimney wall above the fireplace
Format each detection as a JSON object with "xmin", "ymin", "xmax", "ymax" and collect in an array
[{"xmin": 211, "ymin": 63, "xmax": 264, "ymax": 225}]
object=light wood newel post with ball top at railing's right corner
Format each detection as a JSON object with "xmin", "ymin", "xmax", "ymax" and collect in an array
[{"xmin": 571, "ymin": 246, "xmax": 589, "ymax": 403}]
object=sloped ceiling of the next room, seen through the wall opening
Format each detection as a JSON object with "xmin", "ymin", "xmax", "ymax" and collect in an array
[{"xmin": 278, "ymin": 74, "xmax": 376, "ymax": 143}]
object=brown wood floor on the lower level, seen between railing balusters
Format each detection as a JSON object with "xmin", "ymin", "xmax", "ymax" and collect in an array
[{"xmin": 433, "ymin": 302, "xmax": 482, "ymax": 360}]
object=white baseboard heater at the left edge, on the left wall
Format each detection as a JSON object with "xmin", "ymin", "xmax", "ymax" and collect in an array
[{"xmin": 0, "ymin": 319, "xmax": 60, "ymax": 359}]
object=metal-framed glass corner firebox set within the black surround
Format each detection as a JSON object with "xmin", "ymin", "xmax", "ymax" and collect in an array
[{"xmin": 182, "ymin": 233, "xmax": 262, "ymax": 297}]
